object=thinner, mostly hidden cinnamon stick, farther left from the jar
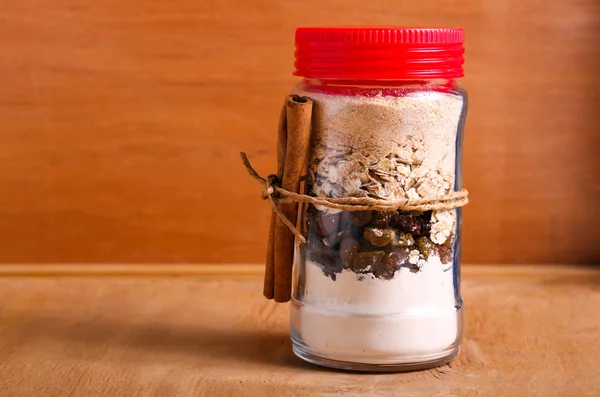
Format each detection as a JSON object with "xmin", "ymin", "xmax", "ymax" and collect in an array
[{"xmin": 263, "ymin": 98, "xmax": 287, "ymax": 299}]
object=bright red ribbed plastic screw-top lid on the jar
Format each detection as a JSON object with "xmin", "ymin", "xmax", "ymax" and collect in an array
[{"xmin": 294, "ymin": 28, "xmax": 465, "ymax": 79}]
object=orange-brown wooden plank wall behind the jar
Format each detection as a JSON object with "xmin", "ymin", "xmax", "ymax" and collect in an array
[{"xmin": 0, "ymin": 0, "xmax": 600, "ymax": 263}]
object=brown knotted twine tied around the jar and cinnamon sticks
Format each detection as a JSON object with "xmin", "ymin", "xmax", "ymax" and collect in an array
[{"xmin": 240, "ymin": 152, "xmax": 469, "ymax": 243}]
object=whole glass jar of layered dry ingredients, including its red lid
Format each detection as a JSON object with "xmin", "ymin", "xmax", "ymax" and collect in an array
[{"xmin": 291, "ymin": 28, "xmax": 467, "ymax": 371}]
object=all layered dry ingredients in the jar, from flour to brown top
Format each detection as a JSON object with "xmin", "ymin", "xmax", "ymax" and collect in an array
[{"xmin": 292, "ymin": 86, "xmax": 463, "ymax": 364}]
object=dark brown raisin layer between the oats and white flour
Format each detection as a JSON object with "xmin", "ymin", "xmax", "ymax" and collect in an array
[{"xmin": 306, "ymin": 206, "xmax": 453, "ymax": 279}]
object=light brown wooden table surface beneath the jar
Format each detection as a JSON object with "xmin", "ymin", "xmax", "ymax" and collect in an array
[{"xmin": 0, "ymin": 266, "xmax": 600, "ymax": 397}]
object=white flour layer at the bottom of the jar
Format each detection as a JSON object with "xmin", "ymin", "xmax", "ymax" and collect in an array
[{"xmin": 292, "ymin": 257, "xmax": 459, "ymax": 363}]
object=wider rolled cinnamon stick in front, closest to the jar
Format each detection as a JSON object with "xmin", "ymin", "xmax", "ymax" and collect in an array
[{"xmin": 273, "ymin": 95, "xmax": 312, "ymax": 302}]
